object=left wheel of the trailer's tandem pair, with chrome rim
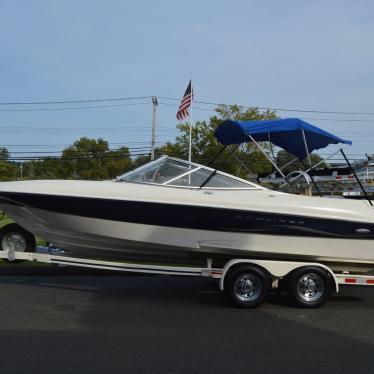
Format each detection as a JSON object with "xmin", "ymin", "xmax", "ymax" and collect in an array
[{"xmin": 225, "ymin": 265, "xmax": 270, "ymax": 308}]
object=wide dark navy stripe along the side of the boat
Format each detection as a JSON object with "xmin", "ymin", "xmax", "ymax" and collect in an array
[{"xmin": 0, "ymin": 192, "xmax": 374, "ymax": 239}]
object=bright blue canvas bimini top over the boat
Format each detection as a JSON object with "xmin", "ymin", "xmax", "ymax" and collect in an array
[{"xmin": 214, "ymin": 118, "xmax": 352, "ymax": 160}]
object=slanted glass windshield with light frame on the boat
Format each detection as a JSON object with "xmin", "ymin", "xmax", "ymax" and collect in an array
[{"xmin": 116, "ymin": 156, "xmax": 261, "ymax": 189}]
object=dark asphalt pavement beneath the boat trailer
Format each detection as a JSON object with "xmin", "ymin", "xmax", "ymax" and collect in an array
[{"xmin": 0, "ymin": 274, "xmax": 374, "ymax": 374}]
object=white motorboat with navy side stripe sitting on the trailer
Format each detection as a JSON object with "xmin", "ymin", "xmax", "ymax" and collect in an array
[{"xmin": 0, "ymin": 121, "xmax": 374, "ymax": 267}]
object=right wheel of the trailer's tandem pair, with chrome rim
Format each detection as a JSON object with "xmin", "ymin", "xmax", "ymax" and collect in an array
[{"xmin": 287, "ymin": 266, "xmax": 332, "ymax": 308}]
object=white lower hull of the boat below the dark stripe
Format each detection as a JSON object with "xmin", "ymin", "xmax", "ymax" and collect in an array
[{"xmin": 3, "ymin": 205, "xmax": 374, "ymax": 264}]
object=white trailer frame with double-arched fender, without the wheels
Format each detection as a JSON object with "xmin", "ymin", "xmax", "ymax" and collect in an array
[{"xmin": 0, "ymin": 246, "xmax": 374, "ymax": 306}]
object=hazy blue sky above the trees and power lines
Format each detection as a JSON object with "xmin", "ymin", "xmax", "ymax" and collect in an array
[{"xmin": 0, "ymin": 0, "xmax": 374, "ymax": 157}]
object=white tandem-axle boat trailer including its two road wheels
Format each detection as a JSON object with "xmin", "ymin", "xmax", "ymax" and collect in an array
[{"xmin": 0, "ymin": 237, "xmax": 374, "ymax": 308}]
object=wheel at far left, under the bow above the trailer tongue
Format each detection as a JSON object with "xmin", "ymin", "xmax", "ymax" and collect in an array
[{"xmin": 0, "ymin": 223, "xmax": 36, "ymax": 260}]
